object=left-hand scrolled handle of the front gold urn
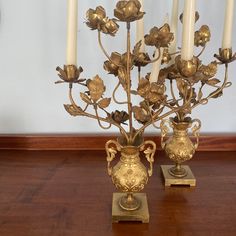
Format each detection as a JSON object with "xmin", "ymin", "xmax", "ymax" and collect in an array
[{"xmin": 105, "ymin": 140, "xmax": 121, "ymax": 176}]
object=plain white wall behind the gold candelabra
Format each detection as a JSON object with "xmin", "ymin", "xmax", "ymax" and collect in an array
[{"xmin": 0, "ymin": 0, "xmax": 236, "ymax": 134}]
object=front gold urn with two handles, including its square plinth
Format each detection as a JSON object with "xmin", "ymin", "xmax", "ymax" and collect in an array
[{"xmin": 106, "ymin": 137, "xmax": 156, "ymax": 222}]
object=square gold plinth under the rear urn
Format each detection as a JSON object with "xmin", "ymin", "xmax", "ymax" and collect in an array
[{"xmin": 161, "ymin": 165, "xmax": 196, "ymax": 187}]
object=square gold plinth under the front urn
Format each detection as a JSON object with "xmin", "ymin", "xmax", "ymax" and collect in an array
[{"xmin": 112, "ymin": 193, "xmax": 149, "ymax": 223}]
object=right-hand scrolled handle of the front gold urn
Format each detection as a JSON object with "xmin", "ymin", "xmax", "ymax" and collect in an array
[{"xmin": 140, "ymin": 140, "xmax": 156, "ymax": 176}]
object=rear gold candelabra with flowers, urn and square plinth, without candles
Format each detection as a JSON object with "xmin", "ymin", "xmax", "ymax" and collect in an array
[{"xmin": 159, "ymin": 20, "xmax": 236, "ymax": 186}]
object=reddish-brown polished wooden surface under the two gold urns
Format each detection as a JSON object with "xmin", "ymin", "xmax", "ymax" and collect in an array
[{"xmin": 0, "ymin": 151, "xmax": 236, "ymax": 236}]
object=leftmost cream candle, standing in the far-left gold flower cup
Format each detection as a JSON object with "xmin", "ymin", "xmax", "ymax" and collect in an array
[{"xmin": 66, "ymin": 0, "xmax": 78, "ymax": 65}]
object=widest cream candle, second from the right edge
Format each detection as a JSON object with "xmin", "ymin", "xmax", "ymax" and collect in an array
[{"xmin": 181, "ymin": 0, "xmax": 196, "ymax": 61}]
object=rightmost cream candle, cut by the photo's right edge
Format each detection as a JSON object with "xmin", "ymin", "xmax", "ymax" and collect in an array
[{"xmin": 222, "ymin": 0, "xmax": 234, "ymax": 48}]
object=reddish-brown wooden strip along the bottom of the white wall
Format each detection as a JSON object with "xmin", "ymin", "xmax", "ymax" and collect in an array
[{"xmin": 0, "ymin": 134, "xmax": 236, "ymax": 151}]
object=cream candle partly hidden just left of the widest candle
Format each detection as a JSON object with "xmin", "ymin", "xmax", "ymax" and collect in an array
[{"xmin": 169, "ymin": 0, "xmax": 179, "ymax": 53}]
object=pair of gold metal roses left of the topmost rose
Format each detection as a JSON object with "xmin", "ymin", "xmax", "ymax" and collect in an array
[{"xmin": 86, "ymin": 6, "xmax": 119, "ymax": 36}]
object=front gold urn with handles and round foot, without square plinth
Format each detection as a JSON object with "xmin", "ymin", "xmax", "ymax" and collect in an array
[{"xmin": 105, "ymin": 138, "xmax": 156, "ymax": 211}]
